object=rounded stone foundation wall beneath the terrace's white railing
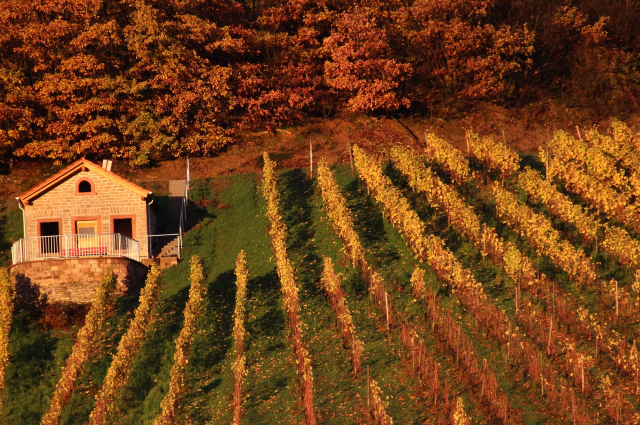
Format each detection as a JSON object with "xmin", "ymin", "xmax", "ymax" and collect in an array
[{"xmin": 9, "ymin": 257, "xmax": 148, "ymax": 303}]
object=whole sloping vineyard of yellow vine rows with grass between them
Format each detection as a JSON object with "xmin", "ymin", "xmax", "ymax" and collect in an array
[{"xmin": 0, "ymin": 123, "xmax": 640, "ymax": 425}]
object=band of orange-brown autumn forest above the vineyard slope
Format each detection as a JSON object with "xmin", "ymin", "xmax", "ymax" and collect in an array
[{"xmin": 0, "ymin": 0, "xmax": 640, "ymax": 165}]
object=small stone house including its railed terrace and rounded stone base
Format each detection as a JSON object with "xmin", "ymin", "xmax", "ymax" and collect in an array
[{"xmin": 9, "ymin": 158, "xmax": 156, "ymax": 303}]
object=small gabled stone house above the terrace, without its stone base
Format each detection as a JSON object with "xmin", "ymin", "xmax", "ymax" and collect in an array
[{"xmin": 18, "ymin": 158, "xmax": 156, "ymax": 260}]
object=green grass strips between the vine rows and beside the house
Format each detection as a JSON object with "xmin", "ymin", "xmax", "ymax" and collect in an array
[{"xmin": 0, "ymin": 157, "xmax": 634, "ymax": 424}]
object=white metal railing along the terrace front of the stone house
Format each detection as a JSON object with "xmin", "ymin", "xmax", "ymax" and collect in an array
[{"xmin": 11, "ymin": 233, "xmax": 140, "ymax": 264}]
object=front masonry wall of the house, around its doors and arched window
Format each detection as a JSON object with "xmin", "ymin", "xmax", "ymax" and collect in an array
[{"xmin": 24, "ymin": 170, "xmax": 147, "ymax": 258}]
